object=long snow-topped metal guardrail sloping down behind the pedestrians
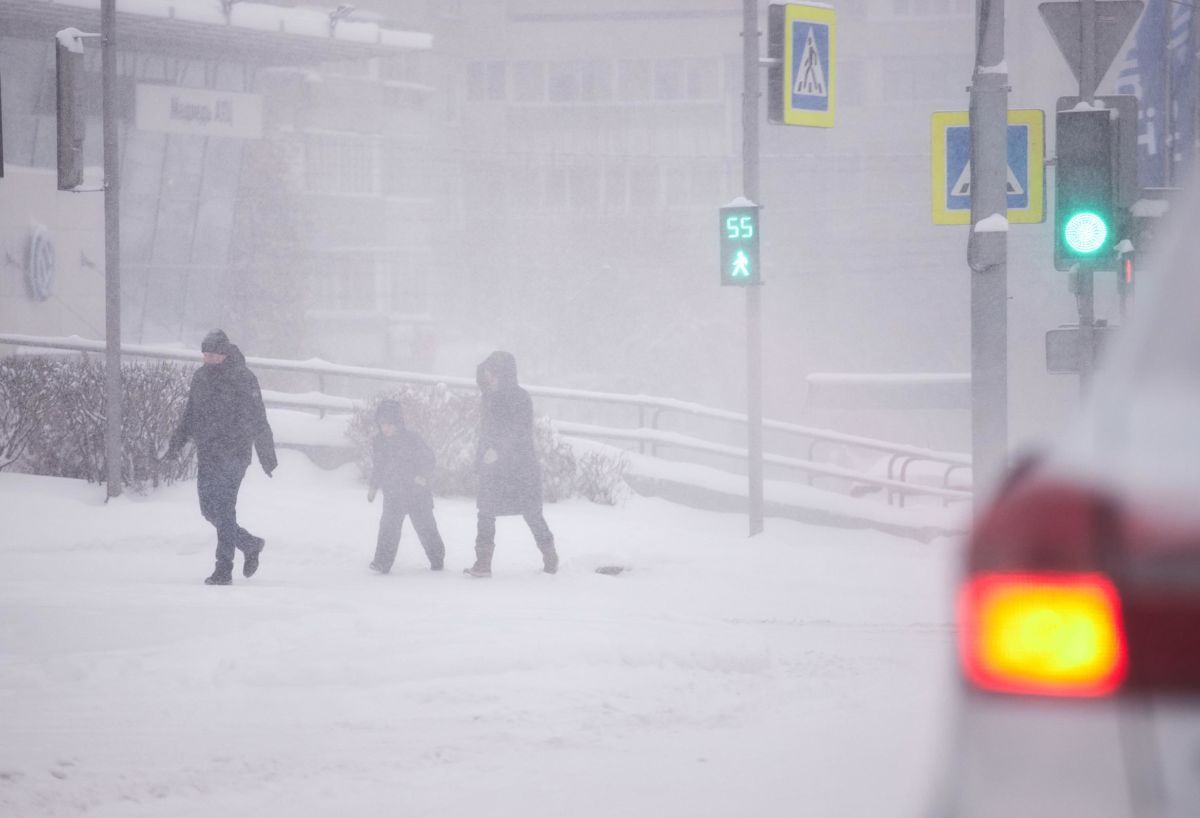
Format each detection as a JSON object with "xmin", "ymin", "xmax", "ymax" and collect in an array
[{"xmin": 0, "ymin": 333, "xmax": 971, "ymax": 506}]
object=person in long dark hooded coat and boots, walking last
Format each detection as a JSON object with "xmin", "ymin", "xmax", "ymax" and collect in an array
[{"xmin": 466, "ymin": 351, "xmax": 558, "ymax": 577}]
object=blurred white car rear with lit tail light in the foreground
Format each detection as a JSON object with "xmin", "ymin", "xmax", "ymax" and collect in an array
[{"xmin": 934, "ymin": 184, "xmax": 1200, "ymax": 818}]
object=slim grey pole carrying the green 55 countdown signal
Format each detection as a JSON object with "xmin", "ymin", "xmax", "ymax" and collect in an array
[{"xmin": 742, "ymin": 0, "xmax": 763, "ymax": 536}]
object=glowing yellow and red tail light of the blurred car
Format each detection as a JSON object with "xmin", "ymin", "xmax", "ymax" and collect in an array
[{"xmin": 959, "ymin": 573, "xmax": 1127, "ymax": 697}]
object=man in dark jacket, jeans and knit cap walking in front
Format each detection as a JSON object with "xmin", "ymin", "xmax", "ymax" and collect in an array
[{"xmin": 167, "ymin": 330, "xmax": 278, "ymax": 585}]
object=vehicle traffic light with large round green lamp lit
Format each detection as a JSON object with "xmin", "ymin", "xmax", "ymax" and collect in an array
[{"xmin": 1054, "ymin": 108, "xmax": 1122, "ymax": 270}]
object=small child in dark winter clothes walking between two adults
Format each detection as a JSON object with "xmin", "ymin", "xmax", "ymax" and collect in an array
[{"xmin": 367, "ymin": 401, "xmax": 446, "ymax": 573}]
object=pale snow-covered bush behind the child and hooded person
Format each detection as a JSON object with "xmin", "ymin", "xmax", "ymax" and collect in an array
[{"xmin": 348, "ymin": 385, "xmax": 624, "ymax": 503}]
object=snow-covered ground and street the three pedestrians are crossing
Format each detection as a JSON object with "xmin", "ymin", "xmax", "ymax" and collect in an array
[{"xmin": 0, "ymin": 451, "xmax": 954, "ymax": 818}]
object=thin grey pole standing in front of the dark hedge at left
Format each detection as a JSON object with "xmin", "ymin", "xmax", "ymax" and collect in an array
[{"xmin": 100, "ymin": 0, "xmax": 122, "ymax": 498}]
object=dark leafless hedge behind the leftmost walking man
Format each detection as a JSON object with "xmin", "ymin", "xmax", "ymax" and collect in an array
[{"xmin": 0, "ymin": 356, "xmax": 194, "ymax": 491}]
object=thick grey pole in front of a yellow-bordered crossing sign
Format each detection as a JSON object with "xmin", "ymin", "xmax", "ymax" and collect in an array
[{"xmin": 967, "ymin": 0, "xmax": 1009, "ymax": 484}]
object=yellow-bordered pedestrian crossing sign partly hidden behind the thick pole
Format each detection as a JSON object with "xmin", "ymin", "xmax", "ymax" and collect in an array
[{"xmin": 931, "ymin": 108, "xmax": 1046, "ymax": 224}]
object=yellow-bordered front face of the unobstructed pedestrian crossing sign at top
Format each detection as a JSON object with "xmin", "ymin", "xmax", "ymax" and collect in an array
[{"xmin": 779, "ymin": 2, "xmax": 838, "ymax": 128}]
